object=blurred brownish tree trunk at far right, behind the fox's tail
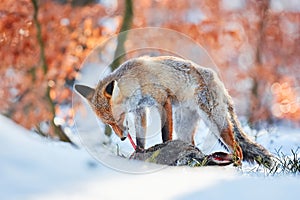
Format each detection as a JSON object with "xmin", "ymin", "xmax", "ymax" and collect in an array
[{"xmin": 248, "ymin": 0, "xmax": 272, "ymax": 128}]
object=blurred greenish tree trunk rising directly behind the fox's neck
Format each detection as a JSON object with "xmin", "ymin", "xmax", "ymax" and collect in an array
[{"xmin": 105, "ymin": 0, "xmax": 133, "ymax": 136}]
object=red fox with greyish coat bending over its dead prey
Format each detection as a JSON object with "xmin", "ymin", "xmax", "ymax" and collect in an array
[{"xmin": 75, "ymin": 56, "xmax": 272, "ymax": 166}]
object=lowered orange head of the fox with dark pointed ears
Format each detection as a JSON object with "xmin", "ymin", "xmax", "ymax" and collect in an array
[{"xmin": 75, "ymin": 81, "xmax": 126, "ymax": 140}]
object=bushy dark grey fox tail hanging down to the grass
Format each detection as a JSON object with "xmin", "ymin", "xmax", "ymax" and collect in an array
[{"xmin": 229, "ymin": 106, "xmax": 273, "ymax": 168}]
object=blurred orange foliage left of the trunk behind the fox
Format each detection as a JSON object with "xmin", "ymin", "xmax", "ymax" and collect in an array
[{"xmin": 0, "ymin": 0, "xmax": 119, "ymax": 135}]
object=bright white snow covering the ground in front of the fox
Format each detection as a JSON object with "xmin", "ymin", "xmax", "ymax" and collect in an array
[{"xmin": 0, "ymin": 116, "xmax": 300, "ymax": 200}]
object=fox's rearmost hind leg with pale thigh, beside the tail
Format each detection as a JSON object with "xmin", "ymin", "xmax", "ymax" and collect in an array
[{"xmin": 195, "ymin": 71, "xmax": 243, "ymax": 165}]
